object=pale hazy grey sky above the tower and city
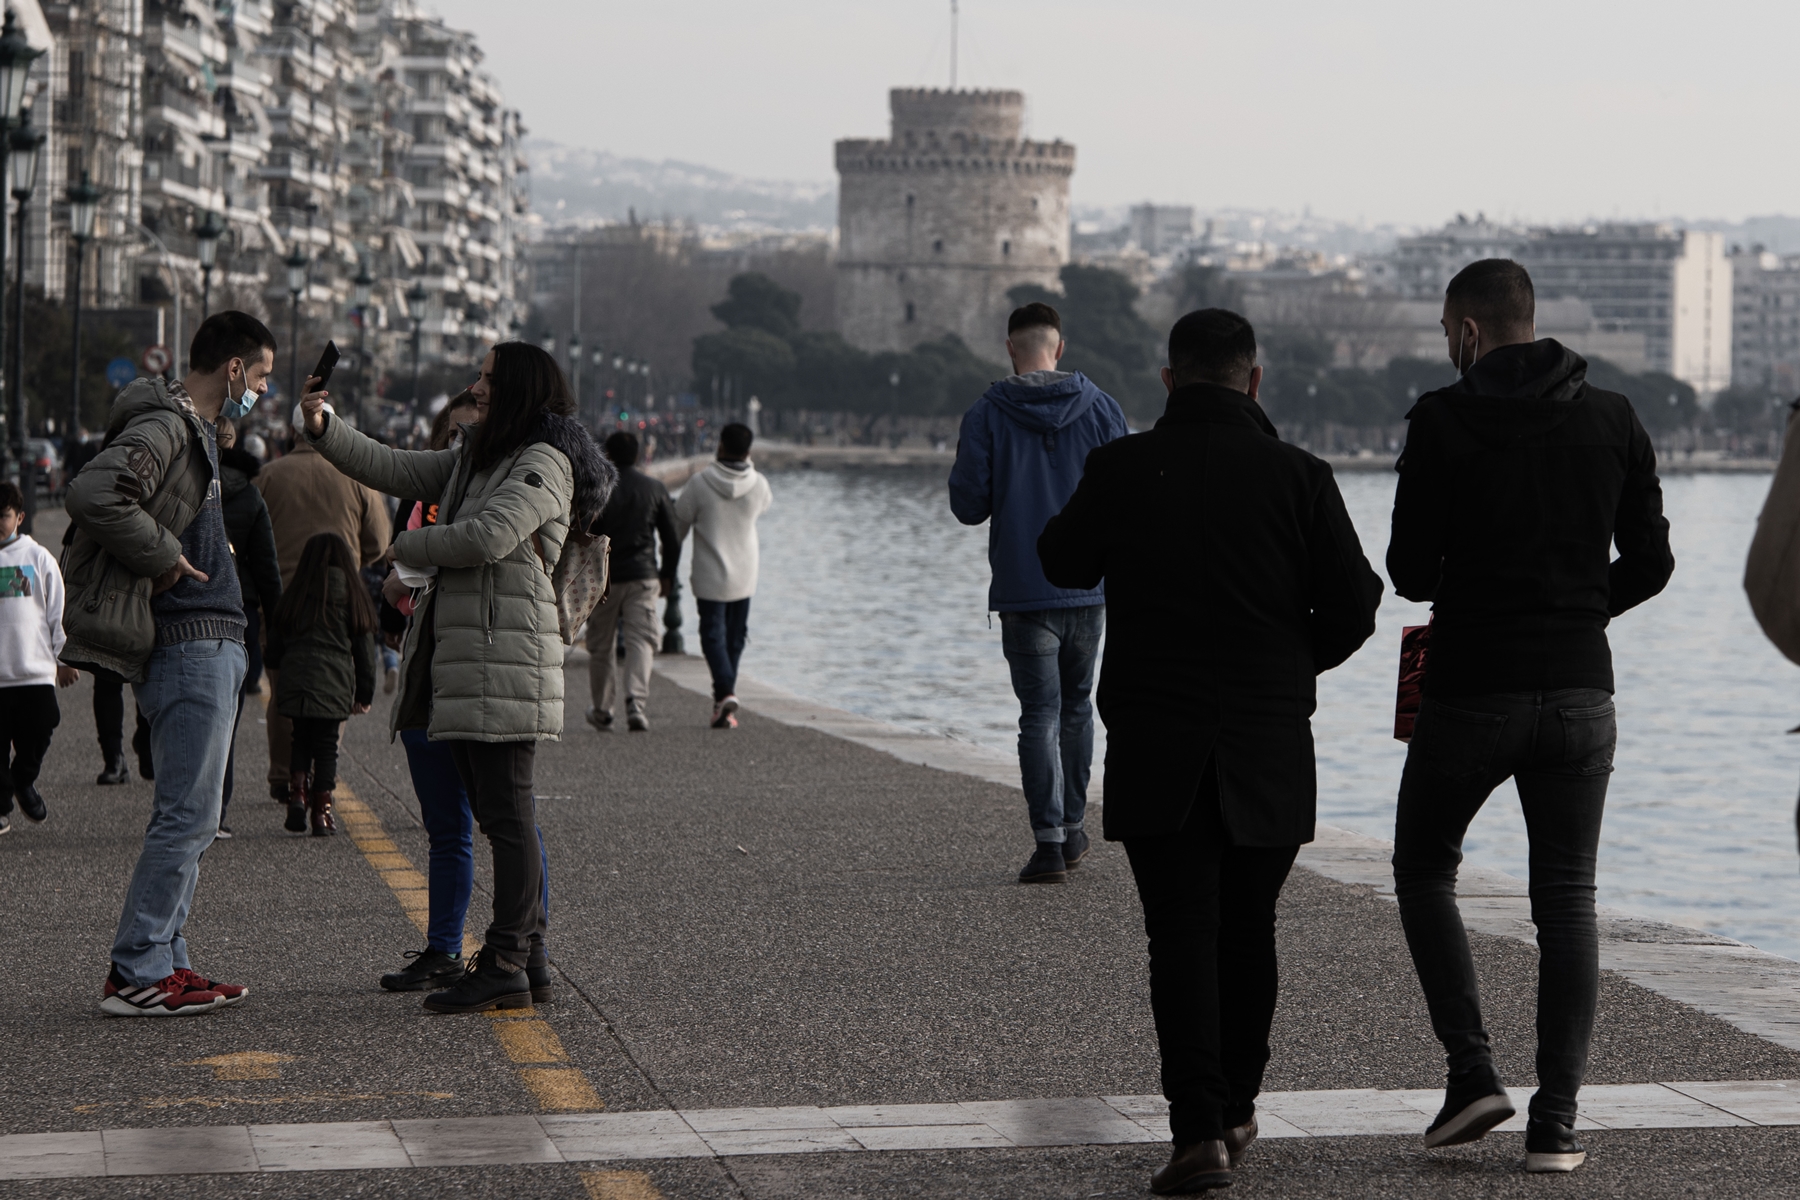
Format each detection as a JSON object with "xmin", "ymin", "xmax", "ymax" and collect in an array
[{"xmin": 430, "ymin": 0, "xmax": 1800, "ymax": 223}]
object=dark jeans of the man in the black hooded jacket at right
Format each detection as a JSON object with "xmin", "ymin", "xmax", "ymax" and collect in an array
[{"xmin": 1393, "ymin": 687, "xmax": 1618, "ymax": 1124}]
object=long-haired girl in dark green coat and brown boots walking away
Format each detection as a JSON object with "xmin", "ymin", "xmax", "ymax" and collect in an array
[{"xmin": 265, "ymin": 533, "xmax": 374, "ymax": 837}]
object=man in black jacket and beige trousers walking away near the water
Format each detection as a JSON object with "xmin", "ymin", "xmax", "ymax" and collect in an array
[{"xmin": 587, "ymin": 430, "xmax": 680, "ymax": 732}]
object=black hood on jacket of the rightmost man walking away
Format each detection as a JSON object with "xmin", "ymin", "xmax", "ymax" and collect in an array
[{"xmin": 1420, "ymin": 338, "xmax": 1588, "ymax": 444}]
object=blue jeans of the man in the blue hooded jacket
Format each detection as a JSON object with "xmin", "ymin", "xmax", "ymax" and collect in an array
[{"xmin": 1001, "ymin": 604, "xmax": 1107, "ymax": 842}]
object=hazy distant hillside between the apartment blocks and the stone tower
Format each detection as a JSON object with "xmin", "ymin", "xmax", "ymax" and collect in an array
[{"xmin": 526, "ymin": 139, "xmax": 837, "ymax": 230}]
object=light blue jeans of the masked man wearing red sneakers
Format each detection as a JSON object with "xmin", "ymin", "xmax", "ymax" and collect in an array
[{"xmin": 112, "ymin": 639, "xmax": 245, "ymax": 988}]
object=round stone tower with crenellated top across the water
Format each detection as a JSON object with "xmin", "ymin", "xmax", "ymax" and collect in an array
[{"xmin": 837, "ymin": 88, "xmax": 1075, "ymax": 362}]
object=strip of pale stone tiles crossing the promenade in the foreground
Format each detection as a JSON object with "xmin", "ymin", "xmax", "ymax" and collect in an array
[{"xmin": 0, "ymin": 1079, "xmax": 1800, "ymax": 1180}]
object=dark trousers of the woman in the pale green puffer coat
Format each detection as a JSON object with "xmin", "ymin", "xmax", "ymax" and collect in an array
[{"xmin": 450, "ymin": 739, "xmax": 549, "ymax": 966}]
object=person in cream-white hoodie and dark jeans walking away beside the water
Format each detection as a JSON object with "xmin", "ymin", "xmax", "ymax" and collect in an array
[{"xmin": 675, "ymin": 425, "xmax": 774, "ymax": 729}]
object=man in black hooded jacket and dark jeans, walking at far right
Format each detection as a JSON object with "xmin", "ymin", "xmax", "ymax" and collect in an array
[{"xmin": 1388, "ymin": 259, "xmax": 1674, "ymax": 1171}]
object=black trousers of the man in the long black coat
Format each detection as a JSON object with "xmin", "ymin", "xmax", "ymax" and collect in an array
[{"xmin": 1125, "ymin": 770, "xmax": 1300, "ymax": 1146}]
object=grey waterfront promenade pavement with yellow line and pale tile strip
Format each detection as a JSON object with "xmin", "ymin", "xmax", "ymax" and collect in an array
[{"xmin": 0, "ymin": 658, "xmax": 1800, "ymax": 1200}]
